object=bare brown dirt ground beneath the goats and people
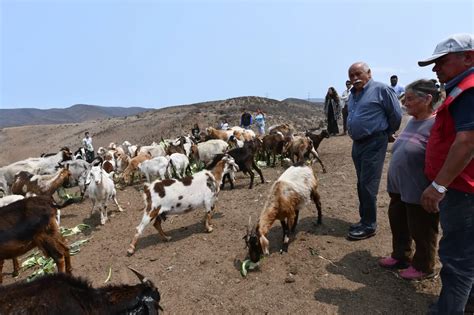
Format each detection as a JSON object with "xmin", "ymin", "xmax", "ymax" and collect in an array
[{"xmin": 2, "ymin": 127, "xmax": 440, "ymax": 314}]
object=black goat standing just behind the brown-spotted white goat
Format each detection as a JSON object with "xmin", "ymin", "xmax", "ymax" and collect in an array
[{"xmin": 206, "ymin": 140, "xmax": 265, "ymax": 189}]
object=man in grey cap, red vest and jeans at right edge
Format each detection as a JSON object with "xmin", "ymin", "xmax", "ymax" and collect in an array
[{"xmin": 418, "ymin": 34, "xmax": 474, "ymax": 314}]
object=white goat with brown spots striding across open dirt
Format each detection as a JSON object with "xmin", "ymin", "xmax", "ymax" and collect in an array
[{"xmin": 127, "ymin": 156, "xmax": 237, "ymax": 256}]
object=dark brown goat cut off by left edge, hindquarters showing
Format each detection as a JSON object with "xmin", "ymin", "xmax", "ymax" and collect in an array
[{"xmin": 0, "ymin": 196, "xmax": 72, "ymax": 284}]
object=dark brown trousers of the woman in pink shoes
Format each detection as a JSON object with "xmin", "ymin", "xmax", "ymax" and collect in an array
[{"xmin": 388, "ymin": 193, "xmax": 439, "ymax": 273}]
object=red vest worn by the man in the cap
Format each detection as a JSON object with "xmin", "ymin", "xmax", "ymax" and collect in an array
[{"xmin": 425, "ymin": 73, "xmax": 474, "ymax": 194}]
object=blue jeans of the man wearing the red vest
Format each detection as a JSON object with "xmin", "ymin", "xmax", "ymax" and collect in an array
[{"xmin": 436, "ymin": 189, "xmax": 474, "ymax": 314}]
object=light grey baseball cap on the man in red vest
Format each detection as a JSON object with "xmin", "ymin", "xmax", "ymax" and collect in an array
[{"xmin": 418, "ymin": 33, "xmax": 474, "ymax": 67}]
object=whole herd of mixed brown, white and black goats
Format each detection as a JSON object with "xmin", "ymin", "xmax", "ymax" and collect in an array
[{"xmin": 0, "ymin": 124, "xmax": 329, "ymax": 314}]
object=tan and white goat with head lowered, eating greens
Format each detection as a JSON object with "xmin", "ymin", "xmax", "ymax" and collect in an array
[{"xmin": 245, "ymin": 163, "xmax": 322, "ymax": 262}]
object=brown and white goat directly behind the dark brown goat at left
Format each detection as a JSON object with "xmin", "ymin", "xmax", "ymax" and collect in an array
[{"xmin": 11, "ymin": 164, "xmax": 71, "ymax": 196}]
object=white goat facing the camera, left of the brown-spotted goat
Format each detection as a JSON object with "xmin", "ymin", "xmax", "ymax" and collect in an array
[{"xmin": 86, "ymin": 166, "xmax": 123, "ymax": 224}]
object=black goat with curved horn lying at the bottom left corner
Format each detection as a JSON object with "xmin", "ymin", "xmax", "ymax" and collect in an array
[{"xmin": 0, "ymin": 268, "xmax": 163, "ymax": 315}]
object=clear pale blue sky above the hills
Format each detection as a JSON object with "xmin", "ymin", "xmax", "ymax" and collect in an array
[{"xmin": 0, "ymin": 0, "xmax": 474, "ymax": 108}]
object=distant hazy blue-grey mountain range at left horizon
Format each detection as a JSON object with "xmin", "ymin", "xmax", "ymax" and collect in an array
[{"xmin": 0, "ymin": 104, "xmax": 152, "ymax": 128}]
